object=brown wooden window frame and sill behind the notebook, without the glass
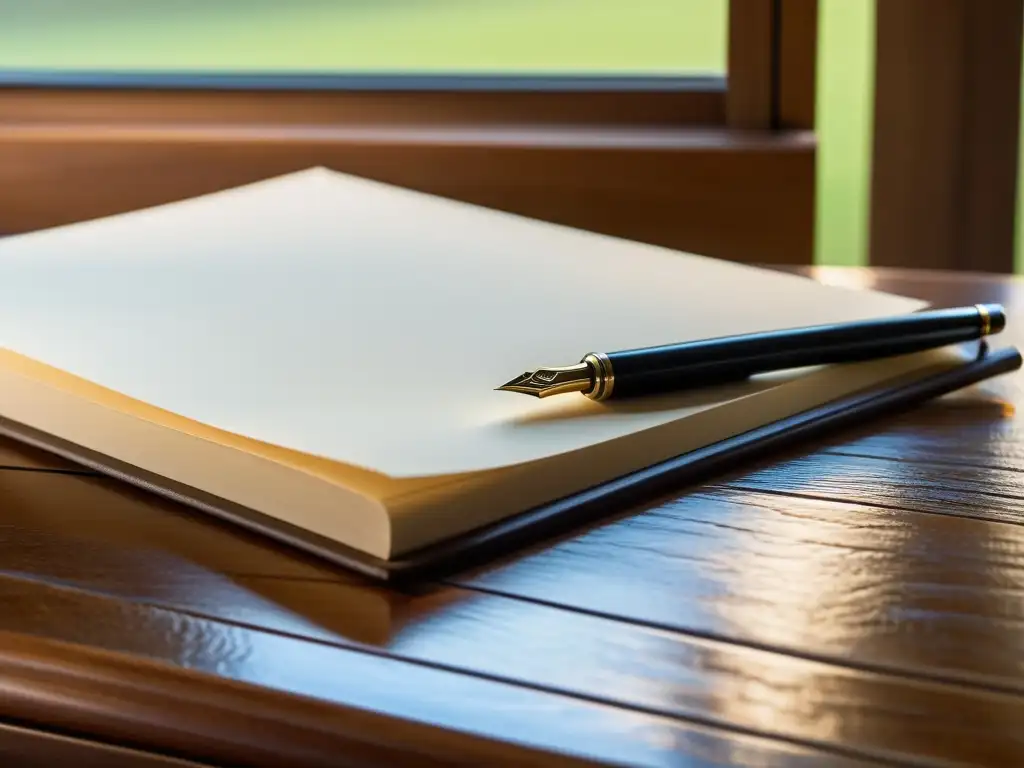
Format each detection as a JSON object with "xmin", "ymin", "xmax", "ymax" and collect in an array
[{"xmin": 0, "ymin": 0, "xmax": 817, "ymax": 263}]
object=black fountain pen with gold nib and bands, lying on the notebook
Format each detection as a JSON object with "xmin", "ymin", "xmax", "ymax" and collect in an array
[{"xmin": 497, "ymin": 304, "xmax": 1007, "ymax": 400}]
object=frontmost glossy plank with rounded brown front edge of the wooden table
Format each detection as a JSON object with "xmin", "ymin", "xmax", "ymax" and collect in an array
[{"xmin": 0, "ymin": 578, "xmax": 876, "ymax": 766}]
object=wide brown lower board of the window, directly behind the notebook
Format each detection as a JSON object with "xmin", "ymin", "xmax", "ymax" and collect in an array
[{"xmin": 0, "ymin": 120, "xmax": 815, "ymax": 263}]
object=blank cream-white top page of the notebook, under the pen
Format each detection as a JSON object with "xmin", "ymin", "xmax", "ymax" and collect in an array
[{"xmin": 0, "ymin": 169, "xmax": 921, "ymax": 476}]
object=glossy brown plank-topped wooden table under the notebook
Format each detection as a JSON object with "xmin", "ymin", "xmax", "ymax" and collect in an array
[{"xmin": 0, "ymin": 269, "xmax": 1024, "ymax": 768}]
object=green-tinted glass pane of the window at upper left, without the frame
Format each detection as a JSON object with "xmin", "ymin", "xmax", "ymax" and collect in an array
[{"xmin": 0, "ymin": 0, "xmax": 728, "ymax": 76}]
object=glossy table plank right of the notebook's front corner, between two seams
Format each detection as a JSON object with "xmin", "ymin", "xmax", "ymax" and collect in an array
[{"xmin": 459, "ymin": 487, "xmax": 1024, "ymax": 691}]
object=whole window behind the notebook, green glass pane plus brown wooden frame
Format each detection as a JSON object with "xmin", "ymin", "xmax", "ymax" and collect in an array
[{"xmin": 0, "ymin": 0, "xmax": 817, "ymax": 262}]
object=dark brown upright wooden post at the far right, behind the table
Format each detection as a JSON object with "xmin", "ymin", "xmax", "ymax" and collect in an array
[{"xmin": 868, "ymin": 0, "xmax": 1024, "ymax": 273}]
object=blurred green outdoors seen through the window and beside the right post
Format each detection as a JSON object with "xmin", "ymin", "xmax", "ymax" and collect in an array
[{"xmin": 0, "ymin": 0, "xmax": 1024, "ymax": 271}]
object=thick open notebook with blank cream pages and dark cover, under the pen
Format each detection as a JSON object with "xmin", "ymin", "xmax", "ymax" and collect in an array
[{"xmin": 0, "ymin": 168, "xmax": 1019, "ymax": 578}]
